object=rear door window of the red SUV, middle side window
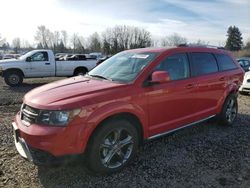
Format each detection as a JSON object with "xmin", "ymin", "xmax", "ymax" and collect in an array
[{"xmin": 190, "ymin": 52, "xmax": 218, "ymax": 76}]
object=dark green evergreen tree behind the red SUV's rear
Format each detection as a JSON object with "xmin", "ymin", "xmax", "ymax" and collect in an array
[{"xmin": 225, "ymin": 26, "xmax": 243, "ymax": 51}]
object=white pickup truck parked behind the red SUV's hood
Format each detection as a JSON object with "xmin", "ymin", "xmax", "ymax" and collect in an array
[{"xmin": 0, "ymin": 50, "xmax": 97, "ymax": 86}]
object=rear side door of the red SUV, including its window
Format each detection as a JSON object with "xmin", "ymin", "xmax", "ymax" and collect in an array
[{"xmin": 190, "ymin": 52, "xmax": 228, "ymax": 119}]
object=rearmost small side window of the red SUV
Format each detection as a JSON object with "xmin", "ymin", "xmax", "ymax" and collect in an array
[{"xmin": 215, "ymin": 54, "xmax": 237, "ymax": 71}]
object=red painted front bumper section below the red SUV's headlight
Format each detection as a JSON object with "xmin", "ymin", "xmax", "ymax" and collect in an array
[{"xmin": 14, "ymin": 112, "xmax": 87, "ymax": 157}]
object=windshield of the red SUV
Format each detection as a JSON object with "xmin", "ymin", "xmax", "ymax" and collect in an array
[{"xmin": 88, "ymin": 52, "xmax": 158, "ymax": 83}]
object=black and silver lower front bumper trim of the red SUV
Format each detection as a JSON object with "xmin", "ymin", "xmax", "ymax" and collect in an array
[{"xmin": 12, "ymin": 122, "xmax": 82, "ymax": 165}]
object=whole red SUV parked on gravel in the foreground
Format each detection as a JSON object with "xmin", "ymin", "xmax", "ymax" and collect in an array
[{"xmin": 13, "ymin": 46, "xmax": 243, "ymax": 173}]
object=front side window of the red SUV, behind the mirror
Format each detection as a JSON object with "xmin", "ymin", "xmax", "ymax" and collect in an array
[{"xmin": 155, "ymin": 53, "xmax": 189, "ymax": 80}]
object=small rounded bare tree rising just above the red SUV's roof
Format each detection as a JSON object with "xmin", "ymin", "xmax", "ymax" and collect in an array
[{"xmin": 161, "ymin": 33, "xmax": 187, "ymax": 47}]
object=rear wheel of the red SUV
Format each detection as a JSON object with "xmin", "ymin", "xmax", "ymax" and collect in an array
[{"xmin": 218, "ymin": 94, "xmax": 238, "ymax": 126}]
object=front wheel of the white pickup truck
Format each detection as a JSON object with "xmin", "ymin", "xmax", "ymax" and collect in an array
[{"xmin": 4, "ymin": 71, "xmax": 23, "ymax": 87}]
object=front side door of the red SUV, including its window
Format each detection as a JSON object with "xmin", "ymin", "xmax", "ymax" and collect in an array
[{"xmin": 145, "ymin": 53, "xmax": 196, "ymax": 136}]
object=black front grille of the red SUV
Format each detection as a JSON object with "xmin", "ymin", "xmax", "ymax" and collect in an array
[{"xmin": 21, "ymin": 104, "xmax": 39, "ymax": 126}]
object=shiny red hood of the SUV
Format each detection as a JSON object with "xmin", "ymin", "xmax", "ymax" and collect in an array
[{"xmin": 24, "ymin": 76, "xmax": 125, "ymax": 110}]
